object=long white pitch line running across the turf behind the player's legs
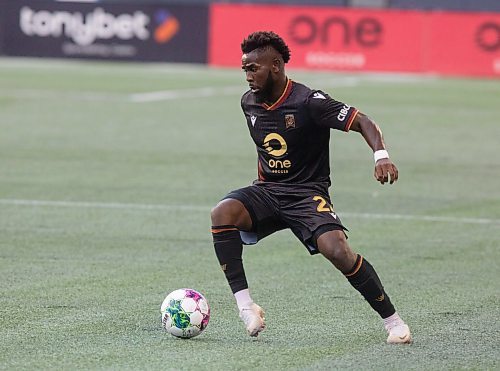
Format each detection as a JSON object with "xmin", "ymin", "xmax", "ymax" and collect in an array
[{"xmin": 0, "ymin": 199, "xmax": 500, "ymax": 226}]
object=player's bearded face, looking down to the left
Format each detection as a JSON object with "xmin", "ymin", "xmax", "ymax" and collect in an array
[{"xmin": 241, "ymin": 51, "xmax": 274, "ymax": 97}]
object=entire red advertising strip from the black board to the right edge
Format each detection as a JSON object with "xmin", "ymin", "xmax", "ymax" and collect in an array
[{"xmin": 209, "ymin": 4, "xmax": 500, "ymax": 76}]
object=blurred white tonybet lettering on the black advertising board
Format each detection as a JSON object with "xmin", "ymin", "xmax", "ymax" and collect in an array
[{"xmin": 19, "ymin": 6, "xmax": 149, "ymax": 45}]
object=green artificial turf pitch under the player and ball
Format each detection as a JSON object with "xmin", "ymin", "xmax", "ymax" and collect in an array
[{"xmin": 0, "ymin": 59, "xmax": 500, "ymax": 370}]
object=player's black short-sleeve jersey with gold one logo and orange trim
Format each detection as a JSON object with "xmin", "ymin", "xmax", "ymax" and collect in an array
[{"xmin": 241, "ymin": 79, "xmax": 358, "ymax": 185}]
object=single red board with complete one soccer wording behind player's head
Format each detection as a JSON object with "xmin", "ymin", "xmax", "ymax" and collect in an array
[{"xmin": 209, "ymin": 4, "xmax": 423, "ymax": 71}]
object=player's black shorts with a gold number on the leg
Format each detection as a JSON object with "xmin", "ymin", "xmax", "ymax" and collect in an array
[{"xmin": 224, "ymin": 182, "xmax": 347, "ymax": 254}]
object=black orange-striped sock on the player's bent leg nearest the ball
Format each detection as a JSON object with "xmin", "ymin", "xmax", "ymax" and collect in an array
[{"xmin": 212, "ymin": 225, "xmax": 248, "ymax": 294}]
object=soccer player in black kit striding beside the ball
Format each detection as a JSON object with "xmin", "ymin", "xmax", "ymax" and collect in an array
[{"xmin": 211, "ymin": 31, "xmax": 412, "ymax": 344}]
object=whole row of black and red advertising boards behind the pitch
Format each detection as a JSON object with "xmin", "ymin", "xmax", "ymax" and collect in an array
[{"xmin": 0, "ymin": 0, "xmax": 500, "ymax": 77}]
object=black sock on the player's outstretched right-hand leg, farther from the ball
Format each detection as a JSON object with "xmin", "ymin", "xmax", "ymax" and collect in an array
[{"xmin": 345, "ymin": 255, "xmax": 396, "ymax": 318}]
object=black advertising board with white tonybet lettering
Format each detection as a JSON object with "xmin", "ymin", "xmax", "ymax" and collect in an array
[{"xmin": 0, "ymin": 0, "xmax": 208, "ymax": 63}]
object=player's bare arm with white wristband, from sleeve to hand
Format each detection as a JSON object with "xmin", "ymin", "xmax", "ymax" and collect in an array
[{"xmin": 350, "ymin": 112, "xmax": 398, "ymax": 184}]
